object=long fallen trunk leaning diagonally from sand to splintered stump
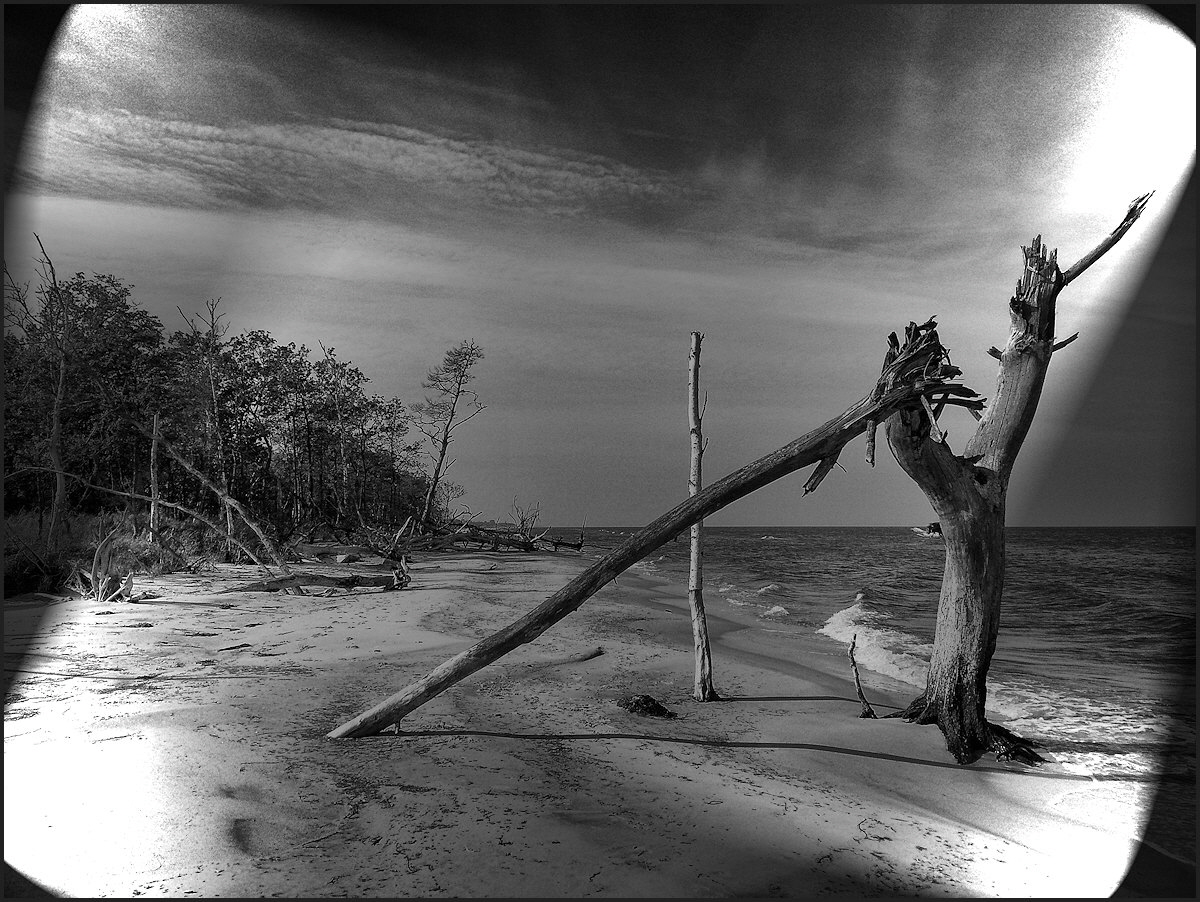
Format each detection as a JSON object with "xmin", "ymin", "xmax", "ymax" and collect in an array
[{"xmin": 329, "ymin": 320, "xmax": 983, "ymax": 739}]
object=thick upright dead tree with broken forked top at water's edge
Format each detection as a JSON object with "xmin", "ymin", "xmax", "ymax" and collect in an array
[{"xmin": 881, "ymin": 194, "xmax": 1150, "ymax": 764}]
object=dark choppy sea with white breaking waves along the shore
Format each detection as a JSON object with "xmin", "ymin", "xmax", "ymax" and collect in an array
[{"xmin": 551, "ymin": 524, "xmax": 1196, "ymax": 860}]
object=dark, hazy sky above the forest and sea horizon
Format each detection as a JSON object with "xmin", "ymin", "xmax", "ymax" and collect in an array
[{"xmin": 5, "ymin": 5, "xmax": 1196, "ymax": 525}]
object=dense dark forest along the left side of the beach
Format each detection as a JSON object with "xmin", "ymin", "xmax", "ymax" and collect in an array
[{"xmin": 4, "ymin": 239, "xmax": 494, "ymax": 594}]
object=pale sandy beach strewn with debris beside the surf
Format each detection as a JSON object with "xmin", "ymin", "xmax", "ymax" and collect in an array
[{"xmin": 5, "ymin": 553, "xmax": 1195, "ymax": 897}]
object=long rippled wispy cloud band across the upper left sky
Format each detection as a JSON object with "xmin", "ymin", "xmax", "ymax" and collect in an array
[{"xmin": 19, "ymin": 107, "xmax": 698, "ymax": 226}]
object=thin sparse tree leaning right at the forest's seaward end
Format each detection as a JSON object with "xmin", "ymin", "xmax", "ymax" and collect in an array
[{"xmin": 413, "ymin": 341, "xmax": 486, "ymax": 530}]
